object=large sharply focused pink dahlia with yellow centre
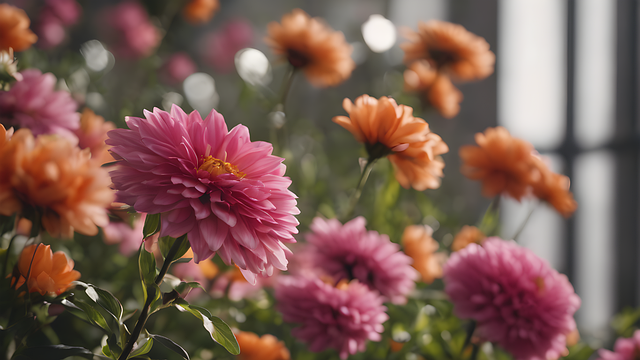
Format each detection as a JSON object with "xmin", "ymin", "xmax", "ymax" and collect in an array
[{"xmin": 107, "ymin": 105, "xmax": 299, "ymax": 282}]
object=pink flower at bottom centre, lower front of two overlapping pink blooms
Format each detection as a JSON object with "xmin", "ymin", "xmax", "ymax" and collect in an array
[{"xmin": 275, "ymin": 276, "xmax": 389, "ymax": 359}]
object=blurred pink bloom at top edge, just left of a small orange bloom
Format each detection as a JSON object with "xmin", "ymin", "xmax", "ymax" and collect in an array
[{"xmin": 105, "ymin": 1, "xmax": 161, "ymax": 59}]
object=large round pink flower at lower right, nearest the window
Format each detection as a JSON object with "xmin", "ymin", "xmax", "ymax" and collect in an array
[{"xmin": 444, "ymin": 237, "xmax": 580, "ymax": 360}]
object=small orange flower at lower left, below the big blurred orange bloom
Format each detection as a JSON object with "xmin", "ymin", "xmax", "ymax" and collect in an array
[{"xmin": 16, "ymin": 244, "xmax": 80, "ymax": 296}]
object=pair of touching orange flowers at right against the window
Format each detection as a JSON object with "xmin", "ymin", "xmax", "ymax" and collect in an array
[{"xmin": 460, "ymin": 127, "xmax": 578, "ymax": 217}]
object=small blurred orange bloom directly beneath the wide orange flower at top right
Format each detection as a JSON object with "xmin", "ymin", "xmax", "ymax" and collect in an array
[{"xmin": 404, "ymin": 61, "xmax": 462, "ymax": 119}]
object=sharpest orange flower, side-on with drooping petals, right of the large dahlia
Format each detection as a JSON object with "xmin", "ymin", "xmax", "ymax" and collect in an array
[{"xmin": 333, "ymin": 95, "xmax": 449, "ymax": 191}]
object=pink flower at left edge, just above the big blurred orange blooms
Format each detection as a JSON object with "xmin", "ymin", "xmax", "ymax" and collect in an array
[{"xmin": 0, "ymin": 69, "xmax": 80, "ymax": 144}]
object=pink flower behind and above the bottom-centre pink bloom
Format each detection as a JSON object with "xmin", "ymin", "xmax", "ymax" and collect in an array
[{"xmin": 305, "ymin": 217, "xmax": 418, "ymax": 304}]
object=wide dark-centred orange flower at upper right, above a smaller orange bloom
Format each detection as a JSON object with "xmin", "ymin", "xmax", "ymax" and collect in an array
[{"xmin": 400, "ymin": 20, "xmax": 496, "ymax": 81}]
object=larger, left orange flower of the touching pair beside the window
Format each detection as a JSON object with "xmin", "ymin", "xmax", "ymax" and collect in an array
[{"xmin": 460, "ymin": 126, "xmax": 540, "ymax": 200}]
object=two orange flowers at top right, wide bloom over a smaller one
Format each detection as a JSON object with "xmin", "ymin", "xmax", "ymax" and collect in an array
[{"xmin": 401, "ymin": 20, "xmax": 495, "ymax": 118}]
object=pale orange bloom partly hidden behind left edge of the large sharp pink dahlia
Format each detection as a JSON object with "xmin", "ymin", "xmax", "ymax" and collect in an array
[{"xmin": 75, "ymin": 108, "xmax": 116, "ymax": 164}]
